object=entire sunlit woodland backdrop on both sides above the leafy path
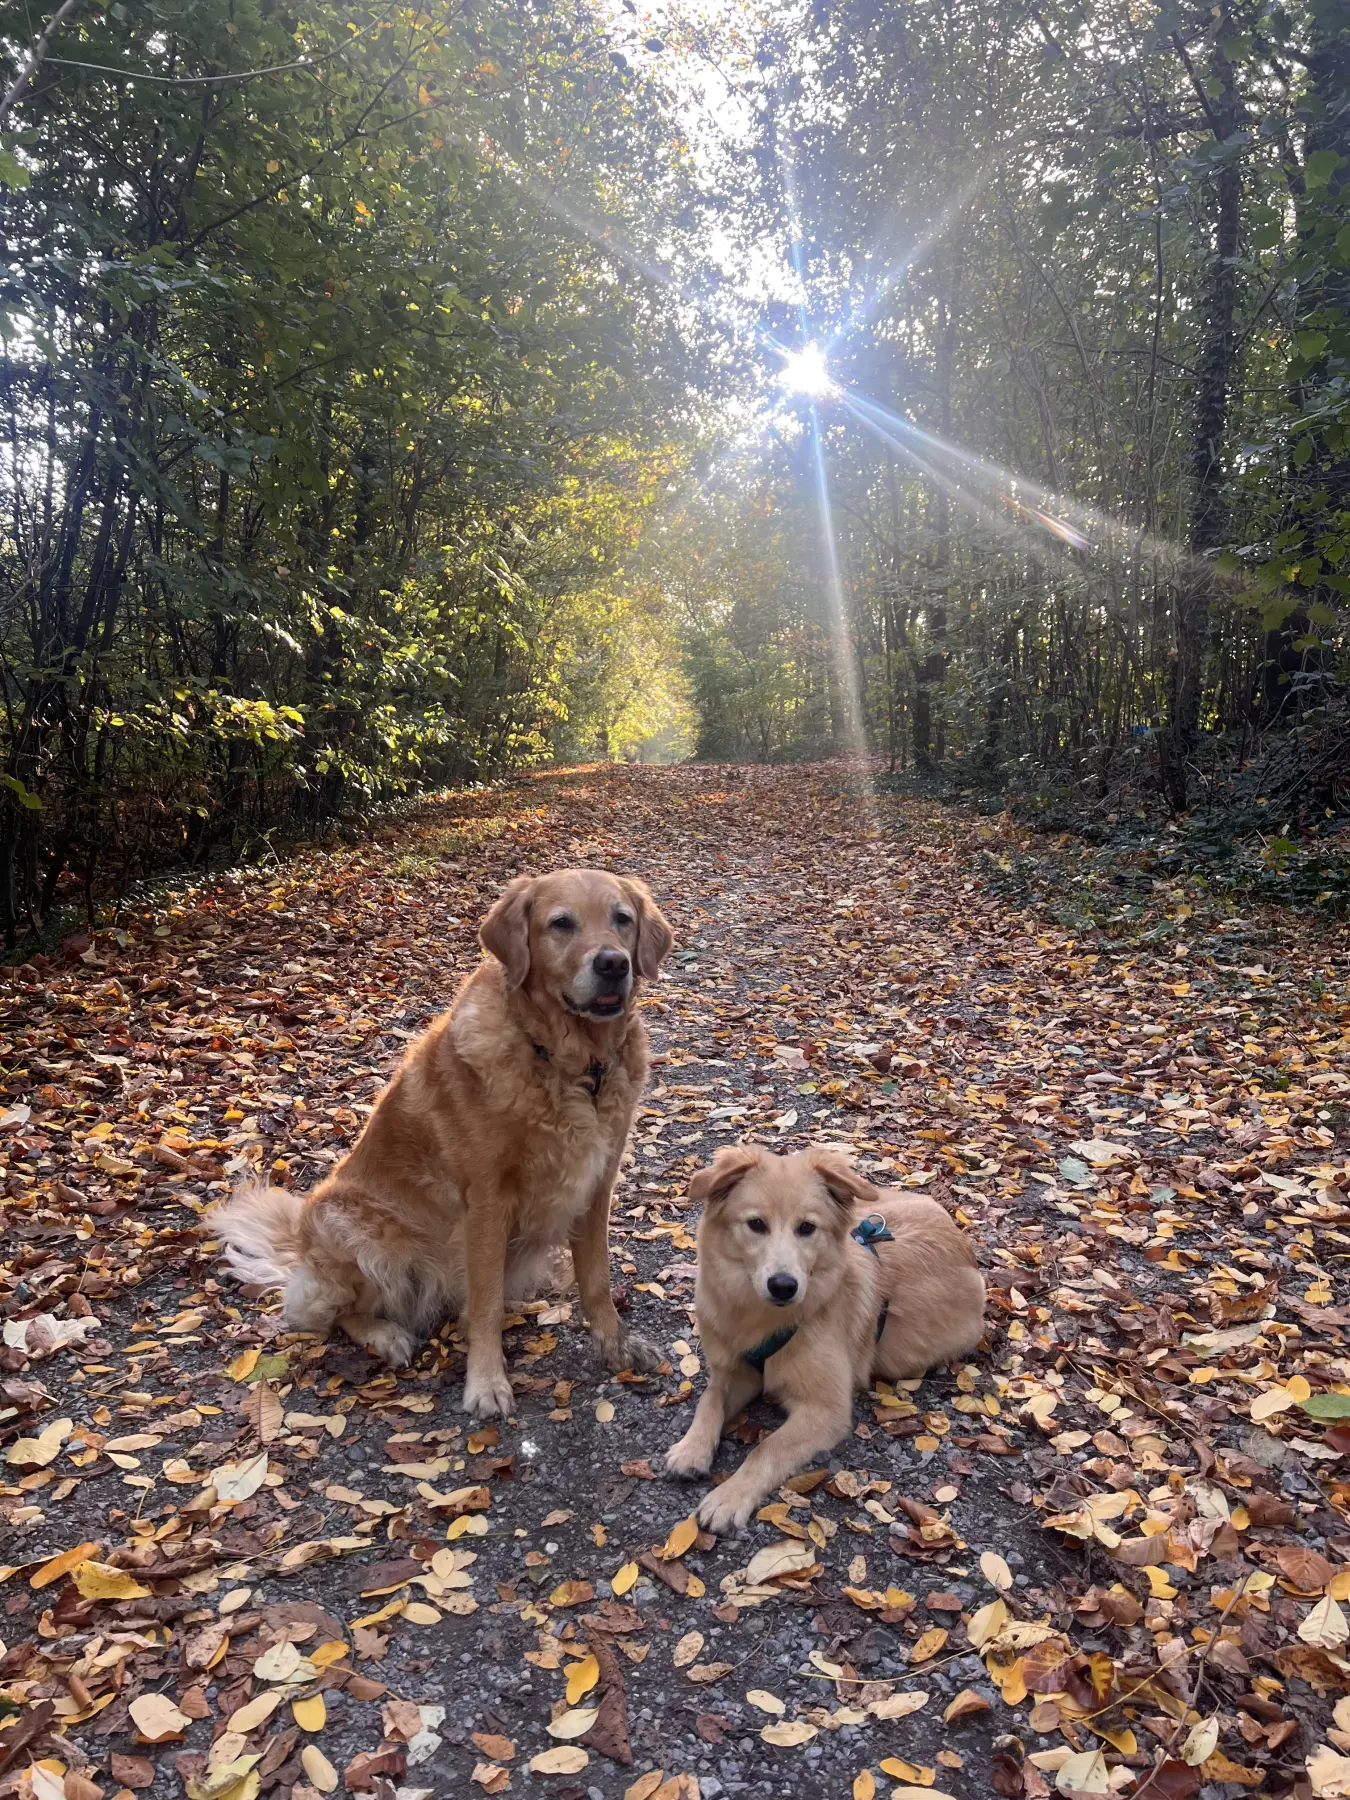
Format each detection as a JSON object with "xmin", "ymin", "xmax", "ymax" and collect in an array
[{"xmin": 0, "ymin": 0, "xmax": 1350, "ymax": 943}]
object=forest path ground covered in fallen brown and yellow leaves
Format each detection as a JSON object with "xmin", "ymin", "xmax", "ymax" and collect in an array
[{"xmin": 0, "ymin": 765, "xmax": 1350, "ymax": 1800}]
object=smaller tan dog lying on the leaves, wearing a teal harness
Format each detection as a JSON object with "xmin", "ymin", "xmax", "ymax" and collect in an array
[{"xmin": 666, "ymin": 1145, "xmax": 985, "ymax": 1532}]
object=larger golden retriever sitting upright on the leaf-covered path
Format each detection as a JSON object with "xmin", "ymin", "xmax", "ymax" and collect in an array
[{"xmin": 212, "ymin": 869, "xmax": 673, "ymax": 1418}]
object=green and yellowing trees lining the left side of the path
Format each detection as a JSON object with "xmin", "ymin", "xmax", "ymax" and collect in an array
[{"xmin": 0, "ymin": 0, "xmax": 697, "ymax": 941}]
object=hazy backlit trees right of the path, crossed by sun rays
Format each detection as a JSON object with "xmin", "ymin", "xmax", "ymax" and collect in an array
[{"xmin": 671, "ymin": 0, "xmax": 1350, "ymax": 810}]
